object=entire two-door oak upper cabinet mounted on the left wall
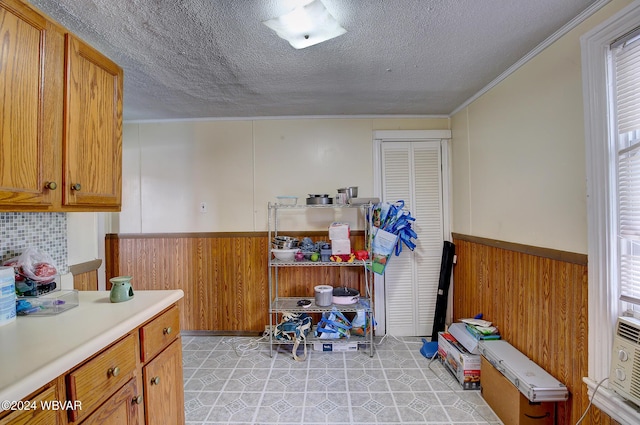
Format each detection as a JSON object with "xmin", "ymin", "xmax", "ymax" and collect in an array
[{"xmin": 0, "ymin": 0, "xmax": 123, "ymax": 211}]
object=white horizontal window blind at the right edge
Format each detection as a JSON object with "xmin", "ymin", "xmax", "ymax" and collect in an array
[{"xmin": 612, "ymin": 28, "xmax": 640, "ymax": 304}]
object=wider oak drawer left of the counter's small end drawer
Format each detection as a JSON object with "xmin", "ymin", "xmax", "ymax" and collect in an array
[{"xmin": 67, "ymin": 334, "xmax": 136, "ymax": 422}]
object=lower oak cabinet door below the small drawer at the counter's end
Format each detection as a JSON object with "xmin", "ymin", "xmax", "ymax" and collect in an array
[{"xmin": 143, "ymin": 338, "xmax": 184, "ymax": 425}]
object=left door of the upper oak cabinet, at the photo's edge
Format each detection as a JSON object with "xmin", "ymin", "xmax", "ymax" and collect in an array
[{"xmin": 0, "ymin": 0, "xmax": 64, "ymax": 210}]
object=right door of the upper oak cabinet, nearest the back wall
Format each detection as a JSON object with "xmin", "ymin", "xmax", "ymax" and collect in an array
[{"xmin": 63, "ymin": 34, "xmax": 123, "ymax": 211}]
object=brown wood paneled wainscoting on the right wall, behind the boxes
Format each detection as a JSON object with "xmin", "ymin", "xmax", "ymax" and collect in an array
[{"xmin": 453, "ymin": 234, "xmax": 614, "ymax": 425}]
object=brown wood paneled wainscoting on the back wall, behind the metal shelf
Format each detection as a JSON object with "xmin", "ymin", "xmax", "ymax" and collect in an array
[{"xmin": 105, "ymin": 231, "xmax": 364, "ymax": 335}]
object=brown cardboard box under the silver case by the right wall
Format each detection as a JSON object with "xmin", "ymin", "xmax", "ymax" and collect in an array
[{"xmin": 481, "ymin": 356, "xmax": 555, "ymax": 425}]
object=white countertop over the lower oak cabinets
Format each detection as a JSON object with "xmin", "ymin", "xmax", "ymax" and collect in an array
[{"xmin": 0, "ymin": 290, "xmax": 184, "ymax": 401}]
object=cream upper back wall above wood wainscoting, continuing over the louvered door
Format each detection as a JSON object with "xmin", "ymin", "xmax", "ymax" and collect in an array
[{"xmin": 117, "ymin": 117, "xmax": 449, "ymax": 233}]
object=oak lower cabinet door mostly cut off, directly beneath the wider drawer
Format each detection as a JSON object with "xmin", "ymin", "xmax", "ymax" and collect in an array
[{"xmin": 82, "ymin": 378, "xmax": 140, "ymax": 425}]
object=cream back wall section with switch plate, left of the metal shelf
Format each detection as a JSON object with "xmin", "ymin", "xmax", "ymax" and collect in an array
[{"xmin": 119, "ymin": 121, "xmax": 253, "ymax": 233}]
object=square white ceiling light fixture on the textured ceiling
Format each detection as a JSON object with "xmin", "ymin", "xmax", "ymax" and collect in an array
[{"xmin": 263, "ymin": 0, "xmax": 347, "ymax": 49}]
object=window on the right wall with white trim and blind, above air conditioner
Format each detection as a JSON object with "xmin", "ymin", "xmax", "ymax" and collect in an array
[{"xmin": 580, "ymin": 1, "xmax": 640, "ymax": 423}]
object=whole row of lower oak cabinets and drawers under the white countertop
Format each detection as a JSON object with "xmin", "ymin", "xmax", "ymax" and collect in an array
[{"xmin": 0, "ymin": 304, "xmax": 184, "ymax": 425}]
